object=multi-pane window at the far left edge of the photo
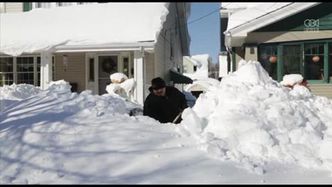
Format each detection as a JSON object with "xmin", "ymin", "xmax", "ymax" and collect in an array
[{"xmin": 0, "ymin": 57, "xmax": 14, "ymax": 86}]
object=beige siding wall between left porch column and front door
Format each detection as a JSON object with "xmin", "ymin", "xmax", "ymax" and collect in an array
[{"xmin": 54, "ymin": 53, "xmax": 86, "ymax": 92}]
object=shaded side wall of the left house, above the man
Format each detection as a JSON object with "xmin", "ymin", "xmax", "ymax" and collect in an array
[{"xmin": 154, "ymin": 3, "xmax": 187, "ymax": 82}]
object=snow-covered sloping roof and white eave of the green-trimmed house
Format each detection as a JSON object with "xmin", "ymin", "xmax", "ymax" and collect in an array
[{"xmin": 224, "ymin": 2, "xmax": 318, "ymax": 46}]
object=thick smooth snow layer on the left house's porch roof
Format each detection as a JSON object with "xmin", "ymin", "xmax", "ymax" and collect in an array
[{"xmin": 0, "ymin": 3, "xmax": 169, "ymax": 56}]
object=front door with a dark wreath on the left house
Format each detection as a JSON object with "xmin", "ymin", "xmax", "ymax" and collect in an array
[{"xmin": 98, "ymin": 56, "xmax": 118, "ymax": 95}]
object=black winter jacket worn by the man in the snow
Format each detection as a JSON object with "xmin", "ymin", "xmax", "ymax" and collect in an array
[{"xmin": 143, "ymin": 86, "xmax": 188, "ymax": 123}]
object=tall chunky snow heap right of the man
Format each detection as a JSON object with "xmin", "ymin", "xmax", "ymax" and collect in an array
[{"xmin": 178, "ymin": 61, "xmax": 332, "ymax": 173}]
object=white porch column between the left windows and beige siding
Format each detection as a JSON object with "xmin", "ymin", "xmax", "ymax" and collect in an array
[{"xmin": 40, "ymin": 52, "xmax": 52, "ymax": 90}]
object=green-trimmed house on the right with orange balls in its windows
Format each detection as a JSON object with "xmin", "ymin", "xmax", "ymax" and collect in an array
[{"xmin": 221, "ymin": 3, "xmax": 332, "ymax": 97}]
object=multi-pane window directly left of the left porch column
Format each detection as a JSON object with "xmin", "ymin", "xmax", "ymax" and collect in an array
[{"xmin": 17, "ymin": 57, "xmax": 34, "ymax": 85}]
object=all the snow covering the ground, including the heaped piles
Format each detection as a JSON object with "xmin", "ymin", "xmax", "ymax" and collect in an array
[{"xmin": 0, "ymin": 62, "xmax": 332, "ymax": 184}]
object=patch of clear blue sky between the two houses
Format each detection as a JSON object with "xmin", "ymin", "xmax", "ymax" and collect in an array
[{"xmin": 188, "ymin": 2, "xmax": 220, "ymax": 63}]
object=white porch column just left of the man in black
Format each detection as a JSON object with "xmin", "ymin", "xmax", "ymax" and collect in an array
[{"xmin": 134, "ymin": 50, "xmax": 145, "ymax": 105}]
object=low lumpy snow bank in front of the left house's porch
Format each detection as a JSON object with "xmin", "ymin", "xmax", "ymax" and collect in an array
[{"xmin": 1, "ymin": 80, "xmax": 137, "ymax": 116}]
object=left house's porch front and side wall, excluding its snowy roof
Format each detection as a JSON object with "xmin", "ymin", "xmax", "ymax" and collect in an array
[{"xmin": 0, "ymin": 3, "xmax": 190, "ymax": 104}]
